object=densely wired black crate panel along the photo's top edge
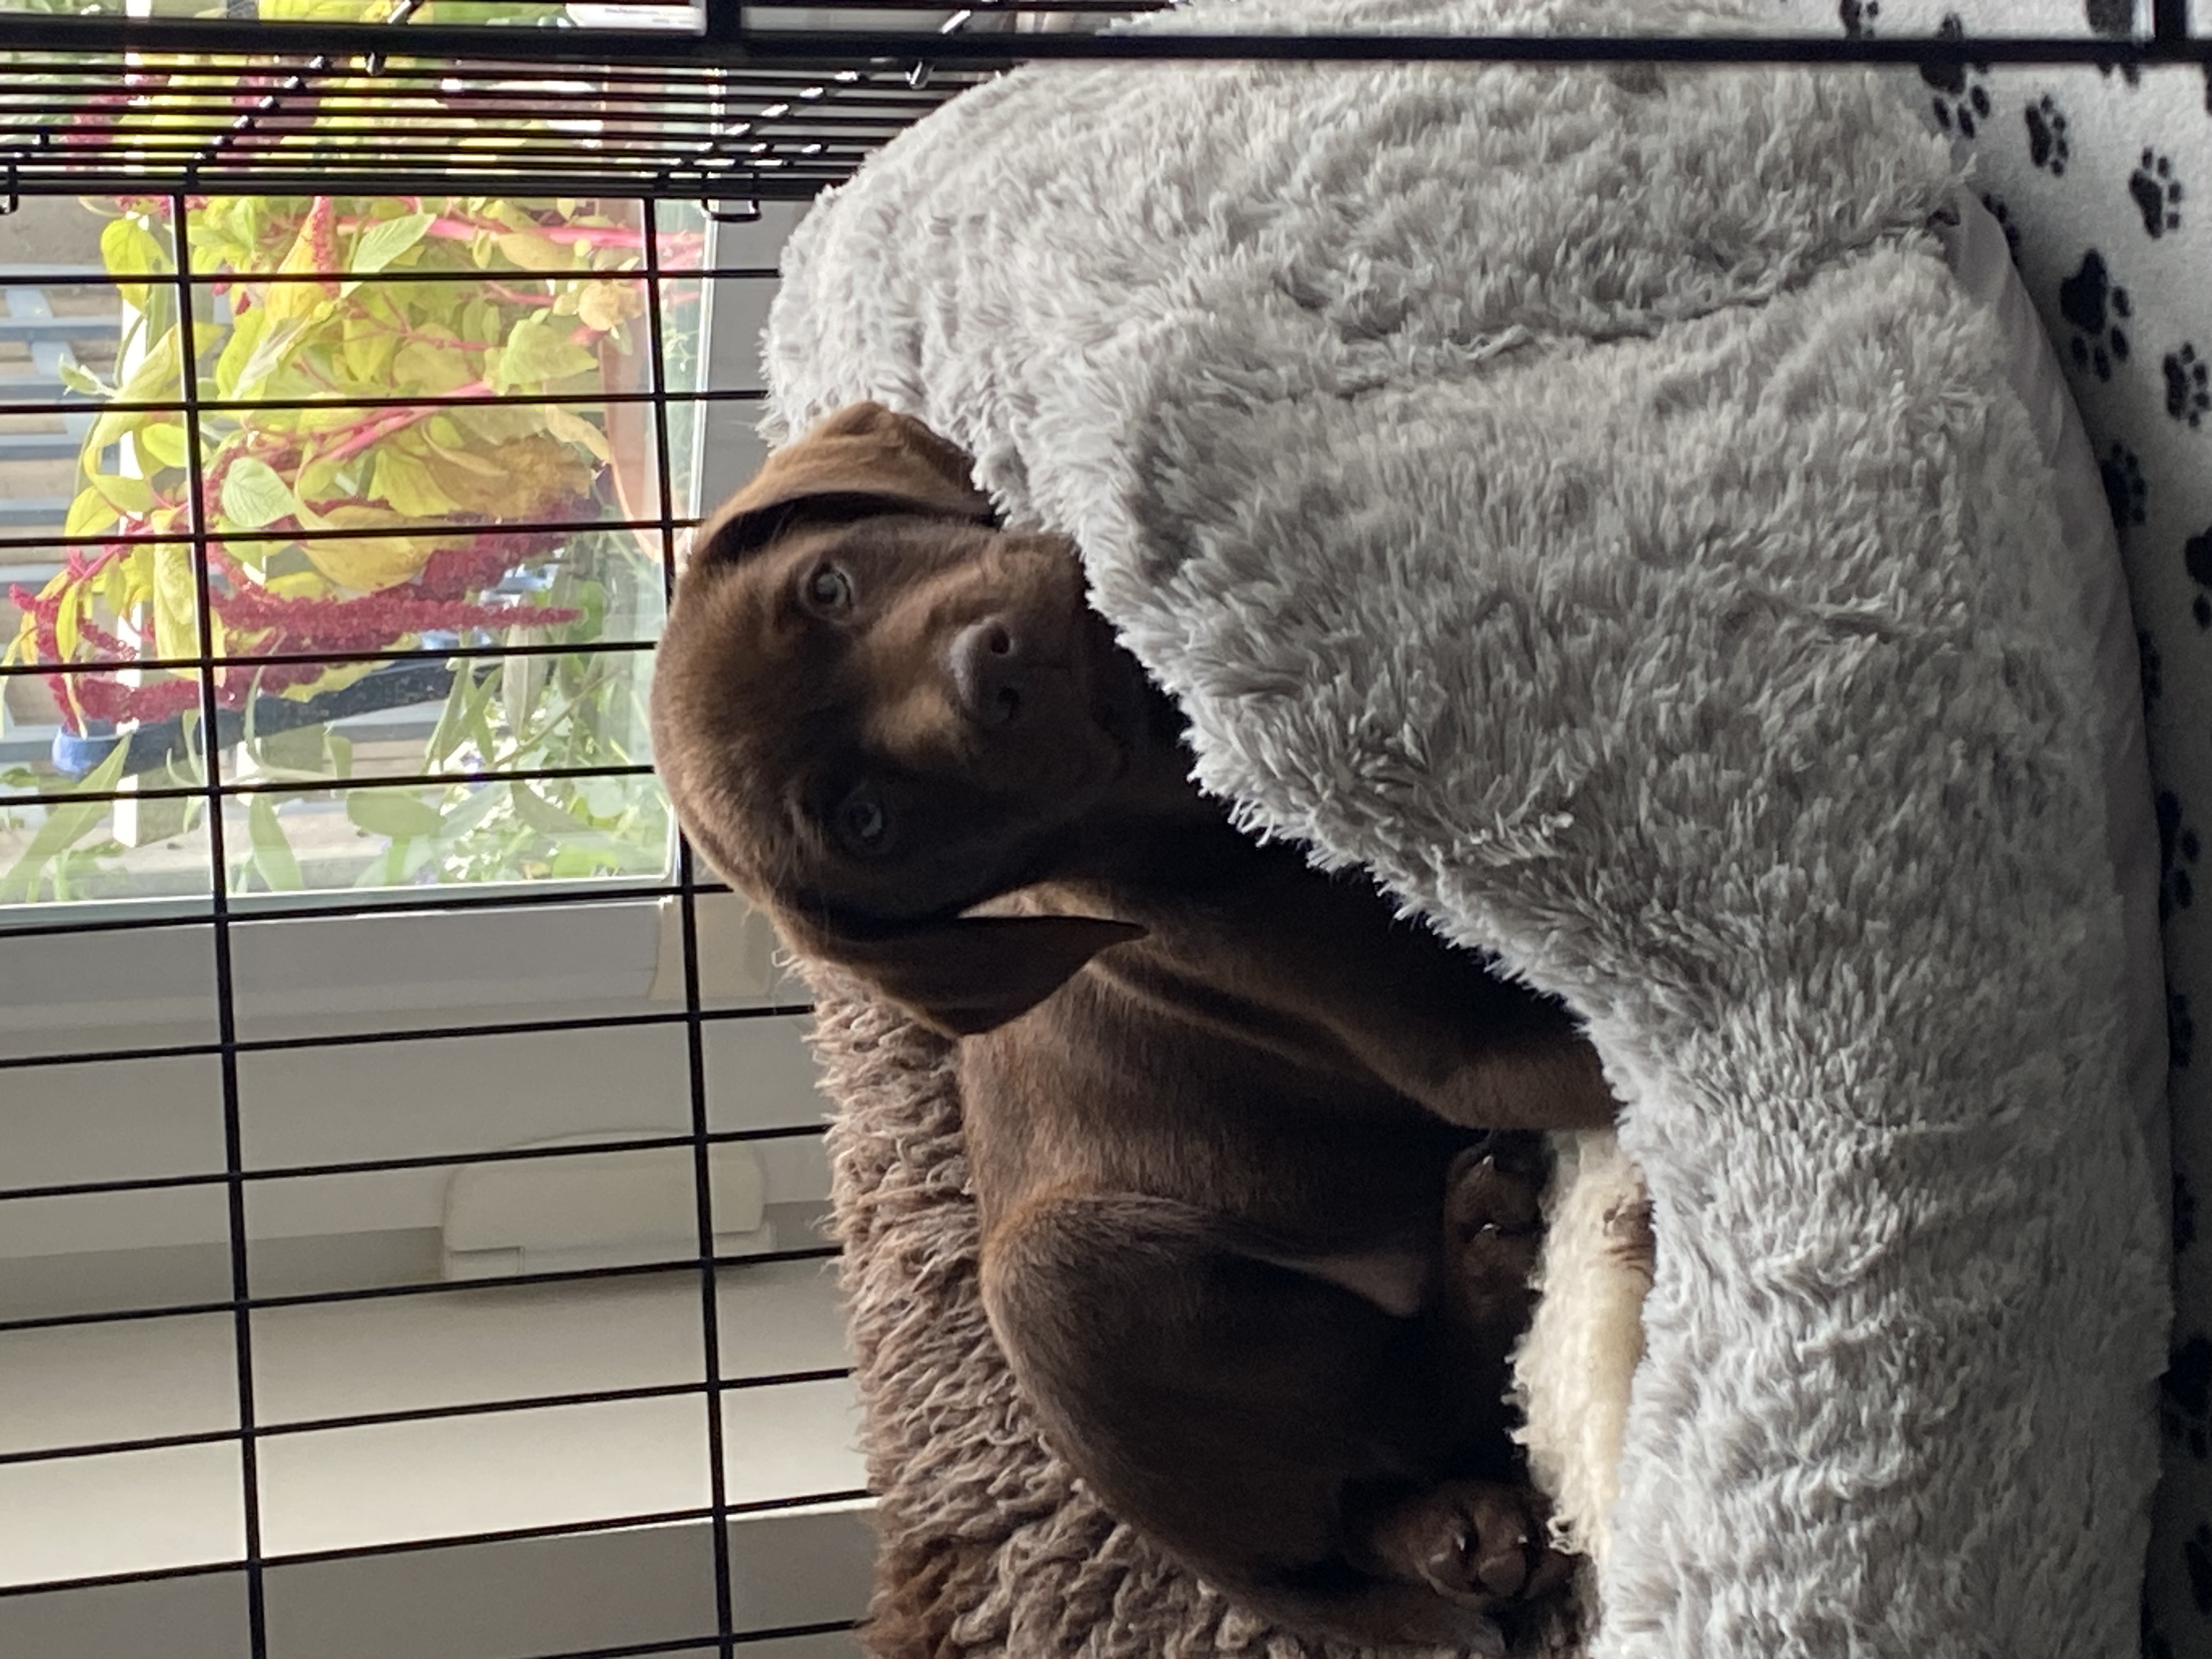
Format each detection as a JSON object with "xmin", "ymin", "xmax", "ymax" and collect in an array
[{"xmin": 0, "ymin": 0, "xmax": 2208, "ymax": 201}]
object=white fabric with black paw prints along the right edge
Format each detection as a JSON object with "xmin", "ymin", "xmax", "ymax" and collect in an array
[{"xmin": 1774, "ymin": 0, "xmax": 2212, "ymax": 1659}]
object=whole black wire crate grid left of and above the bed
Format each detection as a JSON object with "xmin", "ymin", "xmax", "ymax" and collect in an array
[{"xmin": 0, "ymin": 0, "xmax": 2212, "ymax": 1659}]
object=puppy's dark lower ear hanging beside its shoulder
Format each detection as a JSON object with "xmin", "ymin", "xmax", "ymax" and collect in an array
[{"xmin": 778, "ymin": 916, "xmax": 1144, "ymax": 1037}]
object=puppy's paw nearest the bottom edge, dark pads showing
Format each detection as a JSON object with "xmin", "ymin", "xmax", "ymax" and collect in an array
[{"xmin": 1374, "ymin": 1480, "xmax": 1573, "ymax": 1612}]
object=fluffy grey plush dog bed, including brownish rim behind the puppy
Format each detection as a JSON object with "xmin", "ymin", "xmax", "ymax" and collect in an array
[{"xmin": 770, "ymin": 0, "xmax": 2165, "ymax": 1659}]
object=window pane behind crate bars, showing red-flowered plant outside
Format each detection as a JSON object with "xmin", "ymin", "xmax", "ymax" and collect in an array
[{"xmin": 0, "ymin": 197, "xmax": 690, "ymax": 907}]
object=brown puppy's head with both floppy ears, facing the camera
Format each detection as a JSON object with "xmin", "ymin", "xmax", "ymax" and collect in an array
[{"xmin": 652, "ymin": 403, "xmax": 1183, "ymax": 1033}]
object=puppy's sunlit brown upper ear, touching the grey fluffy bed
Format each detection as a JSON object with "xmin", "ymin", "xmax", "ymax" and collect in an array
[{"xmin": 695, "ymin": 403, "xmax": 993, "ymax": 562}]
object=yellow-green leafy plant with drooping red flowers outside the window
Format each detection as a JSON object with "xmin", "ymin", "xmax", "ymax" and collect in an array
[{"xmin": 0, "ymin": 180, "xmax": 701, "ymax": 902}]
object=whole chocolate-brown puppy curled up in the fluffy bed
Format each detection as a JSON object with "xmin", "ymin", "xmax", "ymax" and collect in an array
[{"xmin": 652, "ymin": 405, "xmax": 1615, "ymax": 1646}]
